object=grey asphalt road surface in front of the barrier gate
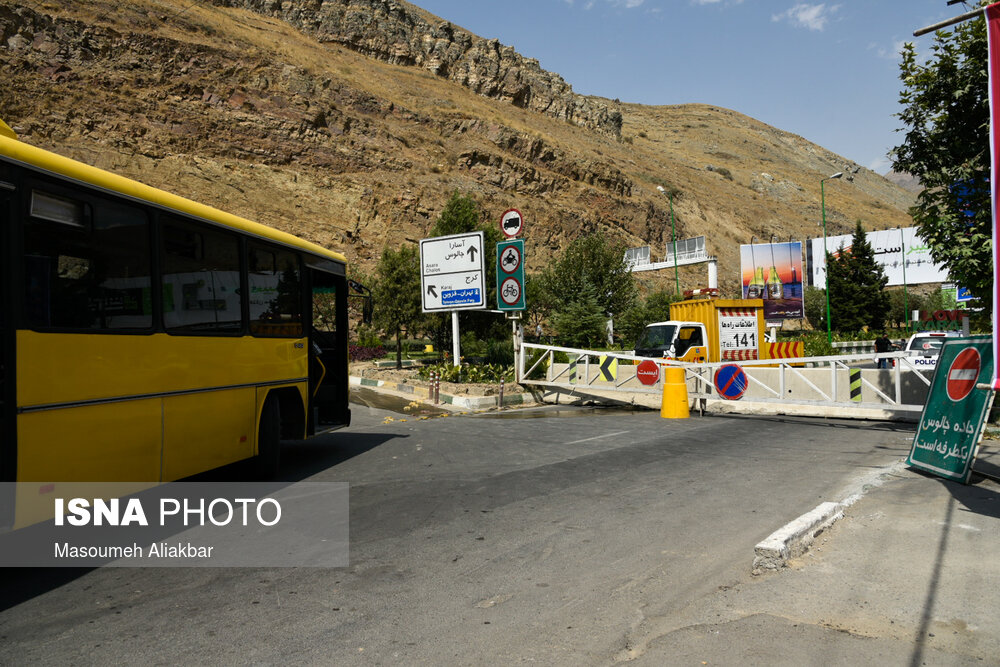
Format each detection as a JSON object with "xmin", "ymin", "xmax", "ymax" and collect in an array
[{"xmin": 0, "ymin": 401, "xmax": 912, "ymax": 665}]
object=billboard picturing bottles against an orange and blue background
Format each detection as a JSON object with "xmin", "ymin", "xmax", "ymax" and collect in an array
[{"xmin": 740, "ymin": 241, "xmax": 805, "ymax": 320}]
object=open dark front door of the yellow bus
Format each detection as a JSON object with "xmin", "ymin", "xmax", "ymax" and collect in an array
[{"xmin": 308, "ymin": 268, "xmax": 351, "ymax": 434}]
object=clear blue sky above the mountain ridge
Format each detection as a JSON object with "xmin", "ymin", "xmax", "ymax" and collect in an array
[{"xmin": 415, "ymin": 0, "xmax": 968, "ymax": 173}]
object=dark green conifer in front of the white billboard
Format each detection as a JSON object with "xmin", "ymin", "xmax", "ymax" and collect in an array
[{"xmin": 826, "ymin": 220, "xmax": 889, "ymax": 331}]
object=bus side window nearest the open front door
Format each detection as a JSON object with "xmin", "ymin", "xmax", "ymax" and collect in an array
[{"xmin": 248, "ymin": 243, "xmax": 303, "ymax": 338}]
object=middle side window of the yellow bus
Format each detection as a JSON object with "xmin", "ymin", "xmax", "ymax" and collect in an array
[{"xmin": 163, "ymin": 220, "xmax": 243, "ymax": 334}]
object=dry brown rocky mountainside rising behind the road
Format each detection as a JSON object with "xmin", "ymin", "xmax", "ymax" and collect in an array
[{"xmin": 0, "ymin": 0, "xmax": 913, "ymax": 294}]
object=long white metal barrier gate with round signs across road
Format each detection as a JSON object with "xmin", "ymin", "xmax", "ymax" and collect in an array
[{"xmin": 517, "ymin": 343, "xmax": 934, "ymax": 421}]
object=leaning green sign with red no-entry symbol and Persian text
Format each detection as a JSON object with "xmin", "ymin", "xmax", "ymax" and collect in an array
[{"xmin": 906, "ymin": 336, "xmax": 993, "ymax": 483}]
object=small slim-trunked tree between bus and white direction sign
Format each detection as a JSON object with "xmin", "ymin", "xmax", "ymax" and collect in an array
[{"xmin": 373, "ymin": 246, "xmax": 421, "ymax": 368}]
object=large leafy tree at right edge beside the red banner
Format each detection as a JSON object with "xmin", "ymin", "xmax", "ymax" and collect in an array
[{"xmin": 892, "ymin": 3, "xmax": 993, "ymax": 303}]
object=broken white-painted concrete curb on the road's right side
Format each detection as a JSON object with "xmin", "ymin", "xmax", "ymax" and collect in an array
[{"xmin": 751, "ymin": 459, "xmax": 906, "ymax": 575}]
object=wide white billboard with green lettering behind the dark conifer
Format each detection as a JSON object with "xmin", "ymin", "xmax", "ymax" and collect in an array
[{"xmin": 809, "ymin": 227, "xmax": 948, "ymax": 287}]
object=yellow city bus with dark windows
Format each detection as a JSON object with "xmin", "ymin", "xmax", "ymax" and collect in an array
[{"xmin": 0, "ymin": 122, "xmax": 351, "ymax": 526}]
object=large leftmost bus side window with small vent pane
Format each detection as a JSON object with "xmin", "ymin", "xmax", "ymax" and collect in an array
[{"xmin": 24, "ymin": 190, "xmax": 153, "ymax": 331}]
